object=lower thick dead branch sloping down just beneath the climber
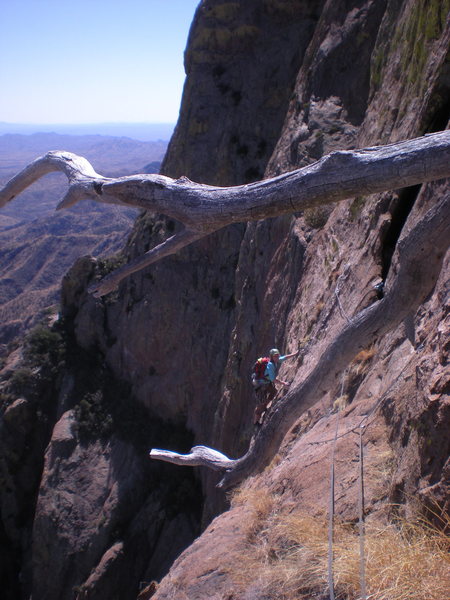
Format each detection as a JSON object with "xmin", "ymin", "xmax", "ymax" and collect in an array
[{"xmin": 150, "ymin": 194, "xmax": 450, "ymax": 489}]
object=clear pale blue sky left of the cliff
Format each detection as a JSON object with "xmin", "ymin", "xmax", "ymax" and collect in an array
[{"xmin": 0, "ymin": 0, "xmax": 199, "ymax": 124}]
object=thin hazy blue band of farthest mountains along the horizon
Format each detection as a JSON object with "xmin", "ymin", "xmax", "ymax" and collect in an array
[{"xmin": 0, "ymin": 121, "xmax": 175, "ymax": 142}]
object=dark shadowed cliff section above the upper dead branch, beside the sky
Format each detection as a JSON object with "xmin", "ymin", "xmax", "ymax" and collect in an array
[{"xmin": 162, "ymin": 0, "xmax": 324, "ymax": 185}]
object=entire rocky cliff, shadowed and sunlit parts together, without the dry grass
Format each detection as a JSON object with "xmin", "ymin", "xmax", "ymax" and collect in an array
[{"xmin": 1, "ymin": 0, "xmax": 450, "ymax": 600}]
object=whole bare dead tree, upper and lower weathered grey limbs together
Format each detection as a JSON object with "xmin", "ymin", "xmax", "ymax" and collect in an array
[{"xmin": 0, "ymin": 131, "xmax": 450, "ymax": 488}]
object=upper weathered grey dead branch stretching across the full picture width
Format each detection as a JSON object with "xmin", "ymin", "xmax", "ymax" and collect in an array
[{"xmin": 0, "ymin": 131, "xmax": 450, "ymax": 296}]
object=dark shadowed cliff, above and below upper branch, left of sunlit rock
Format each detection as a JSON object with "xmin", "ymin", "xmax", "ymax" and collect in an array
[{"xmin": 0, "ymin": 1, "xmax": 330, "ymax": 600}]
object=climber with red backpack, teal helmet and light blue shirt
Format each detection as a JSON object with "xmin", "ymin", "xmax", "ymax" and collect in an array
[{"xmin": 252, "ymin": 348, "xmax": 299, "ymax": 426}]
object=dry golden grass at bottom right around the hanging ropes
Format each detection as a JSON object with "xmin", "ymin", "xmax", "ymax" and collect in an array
[{"xmin": 231, "ymin": 488, "xmax": 450, "ymax": 600}]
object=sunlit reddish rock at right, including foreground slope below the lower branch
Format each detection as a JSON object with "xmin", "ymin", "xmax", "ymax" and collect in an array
[{"xmin": 154, "ymin": 1, "xmax": 450, "ymax": 600}]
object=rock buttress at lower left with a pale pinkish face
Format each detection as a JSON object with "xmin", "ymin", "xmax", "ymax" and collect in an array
[{"xmin": 33, "ymin": 411, "xmax": 198, "ymax": 598}]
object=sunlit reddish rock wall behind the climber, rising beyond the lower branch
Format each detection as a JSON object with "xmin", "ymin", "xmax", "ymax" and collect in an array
[{"xmin": 218, "ymin": 2, "xmax": 449, "ymax": 464}]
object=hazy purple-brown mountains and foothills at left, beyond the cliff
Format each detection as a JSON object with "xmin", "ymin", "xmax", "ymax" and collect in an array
[{"xmin": 0, "ymin": 133, "xmax": 168, "ymax": 346}]
